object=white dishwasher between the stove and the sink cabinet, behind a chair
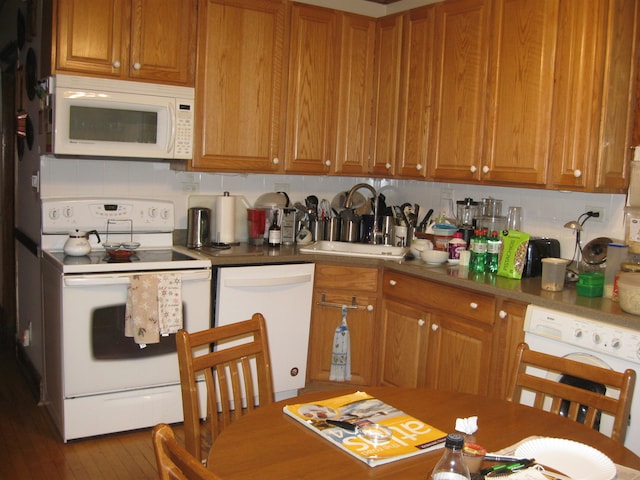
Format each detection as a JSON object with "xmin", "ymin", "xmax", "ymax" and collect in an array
[{"xmin": 214, "ymin": 263, "xmax": 315, "ymax": 401}]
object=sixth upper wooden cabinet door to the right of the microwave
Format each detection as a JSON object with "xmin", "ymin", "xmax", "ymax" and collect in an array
[{"xmin": 429, "ymin": 0, "xmax": 491, "ymax": 181}]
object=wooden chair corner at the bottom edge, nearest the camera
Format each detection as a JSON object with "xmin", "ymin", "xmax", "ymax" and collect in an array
[{"xmin": 151, "ymin": 423, "xmax": 221, "ymax": 480}]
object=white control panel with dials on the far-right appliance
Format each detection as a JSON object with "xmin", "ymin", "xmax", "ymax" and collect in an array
[{"xmin": 524, "ymin": 305, "xmax": 640, "ymax": 364}]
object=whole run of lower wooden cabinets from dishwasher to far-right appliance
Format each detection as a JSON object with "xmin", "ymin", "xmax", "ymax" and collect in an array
[{"xmin": 308, "ymin": 265, "xmax": 527, "ymax": 397}]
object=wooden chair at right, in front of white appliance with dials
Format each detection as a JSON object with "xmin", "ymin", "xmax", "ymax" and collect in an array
[{"xmin": 507, "ymin": 343, "xmax": 636, "ymax": 443}]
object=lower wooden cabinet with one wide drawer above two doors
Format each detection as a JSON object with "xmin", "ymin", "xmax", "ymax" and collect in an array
[{"xmin": 379, "ymin": 272, "xmax": 495, "ymax": 394}]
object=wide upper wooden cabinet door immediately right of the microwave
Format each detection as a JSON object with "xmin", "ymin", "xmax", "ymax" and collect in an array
[{"xmin": 192, "ymin": 0, "xmax": 287, "ymax": 172}]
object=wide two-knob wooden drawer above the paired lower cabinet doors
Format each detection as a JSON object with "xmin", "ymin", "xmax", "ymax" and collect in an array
[{"xmin": 383, "ymin": 272, "xmax": 495, "ymax": 325}]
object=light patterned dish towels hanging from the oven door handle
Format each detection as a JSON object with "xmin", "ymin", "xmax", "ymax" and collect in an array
[{"xmin": 125, "ymin": 273, "xmax": 182, "ymax": 348}]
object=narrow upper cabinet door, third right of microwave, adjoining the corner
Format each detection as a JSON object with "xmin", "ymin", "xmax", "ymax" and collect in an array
[{"xmin": 332, "ymin": 14, "xmax": 375, "ymax": 175}]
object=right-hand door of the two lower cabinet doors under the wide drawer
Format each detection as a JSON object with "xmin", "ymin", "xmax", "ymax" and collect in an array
[{"xmin": 426, "ymin": 313, "xmax": 492, "ymax": 395}]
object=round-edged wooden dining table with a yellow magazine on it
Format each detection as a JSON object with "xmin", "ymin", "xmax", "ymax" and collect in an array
[{"xmin": 208, "ymin": 387, "xmax": 640, "ymax": 480}]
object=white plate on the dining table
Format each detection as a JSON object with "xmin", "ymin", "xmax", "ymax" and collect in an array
[{"xmin": 515, "ymin": 437, "xmax": 616, "ymax": 480}]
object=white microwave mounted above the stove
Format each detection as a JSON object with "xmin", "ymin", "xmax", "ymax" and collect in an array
[{"xmin": 40, "ymin": 75, "xmax": 194, "ymax": 160}]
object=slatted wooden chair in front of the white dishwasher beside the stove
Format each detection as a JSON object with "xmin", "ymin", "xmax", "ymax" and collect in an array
[{"xmin": 176, "ymin": 313, "xmax": 274, "ymax": 459}]
